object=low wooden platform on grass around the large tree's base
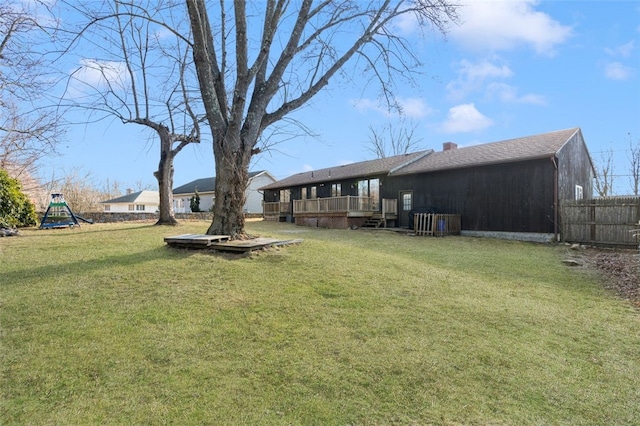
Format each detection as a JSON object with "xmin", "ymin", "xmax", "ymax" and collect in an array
[{"xmin": 164, "ymin": 234, "xmax": 302, "ymax": 252}]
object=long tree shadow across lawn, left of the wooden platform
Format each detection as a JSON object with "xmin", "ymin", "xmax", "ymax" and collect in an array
[{"xmin": 0, "ymin": 245, "xmax": 196, "ymax": 285}]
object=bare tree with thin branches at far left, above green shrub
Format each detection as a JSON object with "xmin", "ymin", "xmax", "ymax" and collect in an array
[{"xmin": 0, "ymin": 0, "xmax": 63, "ymax": 188}]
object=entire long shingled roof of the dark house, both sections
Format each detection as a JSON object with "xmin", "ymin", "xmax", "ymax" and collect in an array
[{"xmin": 260, "ymin": 127, "xmax": 580, "ymax": 190}]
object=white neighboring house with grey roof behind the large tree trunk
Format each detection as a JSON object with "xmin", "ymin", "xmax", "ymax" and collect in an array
[{"xmin": 173, "ymin": 170, "xmax": 276, "ymax": 214}]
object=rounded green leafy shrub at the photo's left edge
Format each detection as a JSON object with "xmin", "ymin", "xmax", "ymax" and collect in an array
[{"xmin": 0, "ymin": 169, "xmax": 37, "ymax": 227}]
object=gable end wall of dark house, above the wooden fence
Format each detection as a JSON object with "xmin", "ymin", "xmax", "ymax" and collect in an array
[{"xmin": 558, "ymin": 132, "xmax": 594, "ymax": 200}]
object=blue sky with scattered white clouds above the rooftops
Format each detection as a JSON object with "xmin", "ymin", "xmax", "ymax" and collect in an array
[{"xmin": 42, "ymin": 0, "xmax": 640, "ymax": 195}]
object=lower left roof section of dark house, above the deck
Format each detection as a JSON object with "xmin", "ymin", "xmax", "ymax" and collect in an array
[{"xmin": 260, "ymin": 150, "xmax": 433, "ymax": 190}]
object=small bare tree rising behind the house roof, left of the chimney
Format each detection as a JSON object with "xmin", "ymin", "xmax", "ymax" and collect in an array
[{"xmin": 367, "ymin": 122, "xmax": 421, "ymax": 158}]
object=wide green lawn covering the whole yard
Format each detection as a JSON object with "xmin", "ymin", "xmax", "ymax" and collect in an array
[{"xmin": 0, "ymin": 222, "xmax": 640, "ymax": 425}]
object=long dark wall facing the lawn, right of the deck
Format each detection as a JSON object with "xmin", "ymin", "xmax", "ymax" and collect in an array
[{"xmin": 382, "ymin": 159, "xmax": 554, "ymax": 233}]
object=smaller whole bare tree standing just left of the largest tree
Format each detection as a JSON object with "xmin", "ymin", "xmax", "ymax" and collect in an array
[{"xmin": 62, "ymin": 1, "xmax": 204, "ymax": 225}]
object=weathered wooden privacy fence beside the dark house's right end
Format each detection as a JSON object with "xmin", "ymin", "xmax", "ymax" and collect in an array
[{"xmin": 560, "ymin": 197, "xmax": 640, "ymax": 247}]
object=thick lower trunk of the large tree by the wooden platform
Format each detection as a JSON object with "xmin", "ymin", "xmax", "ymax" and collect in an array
[{"xmin": 207, "ymin": 137, "xmax": 251, "ymax": 240}]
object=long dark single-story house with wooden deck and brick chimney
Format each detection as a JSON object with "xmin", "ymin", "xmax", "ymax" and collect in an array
[{"xmin": 261, "ymin": 128, "xmax": 595, "ymax": 240}]
